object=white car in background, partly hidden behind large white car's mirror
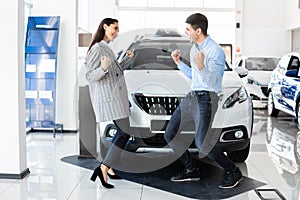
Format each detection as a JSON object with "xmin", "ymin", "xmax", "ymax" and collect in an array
[{"xmin": 234, "ymin": 56, "xmax": 280, "ymax": 107}]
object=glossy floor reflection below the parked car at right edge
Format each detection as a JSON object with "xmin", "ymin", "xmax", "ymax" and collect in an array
[{"xmin": 266, "ymin": 116, "xmax": 300, "ymax": 199}]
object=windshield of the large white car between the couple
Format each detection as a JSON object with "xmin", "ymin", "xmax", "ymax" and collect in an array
[{"xmin": 121, "ymin": 40, "xmax": 231, "ymax": 70}]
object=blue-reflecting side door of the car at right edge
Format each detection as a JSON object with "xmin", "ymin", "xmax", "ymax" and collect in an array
[{"xmin": 280, "ymin": 55, "xmax": 299, "ymax": 116}]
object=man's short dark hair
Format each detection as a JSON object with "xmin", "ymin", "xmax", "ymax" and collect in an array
[{"xmin": 185, "ymin": 13, "xmax": 208, "ymax": 35}]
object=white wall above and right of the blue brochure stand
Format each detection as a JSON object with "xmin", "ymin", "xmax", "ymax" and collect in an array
[{"xmin": 32, "ymin": 0, "xmax": 78, "ymax": 130}]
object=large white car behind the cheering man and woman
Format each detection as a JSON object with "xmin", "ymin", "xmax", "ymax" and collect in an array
[{"xmin": 100, "ymin": 31, "xmax": 253, "ymax": 162}]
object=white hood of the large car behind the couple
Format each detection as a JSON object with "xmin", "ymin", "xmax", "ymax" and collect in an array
[{"xmin": 125, "ymin": 70, "xmax": 242, "ymax": 96}]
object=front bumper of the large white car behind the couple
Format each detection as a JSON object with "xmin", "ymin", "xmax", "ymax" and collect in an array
[{"xmin": 99, "ymin": 91, "xmax": 253, "ymax": 154}]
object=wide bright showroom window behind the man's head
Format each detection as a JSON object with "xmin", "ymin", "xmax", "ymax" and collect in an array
[{"xmin": 115, "ymin": 0, "xmax": 236, "ymax": 47}]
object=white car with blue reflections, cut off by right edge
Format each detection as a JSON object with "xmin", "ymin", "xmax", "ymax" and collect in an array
[{"xmin": 268, "ymin": 52, "xmax": 300, "ymax": 127}]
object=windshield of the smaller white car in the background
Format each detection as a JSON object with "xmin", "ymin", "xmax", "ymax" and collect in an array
[{"xmin": 246, "ymin": 57, "xmax": 279, "ymax": 71}]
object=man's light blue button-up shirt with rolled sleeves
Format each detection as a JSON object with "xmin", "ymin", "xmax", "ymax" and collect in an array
[{"xmin": 178, "ymin": 36, "xmax": 225, "ymax": 93}]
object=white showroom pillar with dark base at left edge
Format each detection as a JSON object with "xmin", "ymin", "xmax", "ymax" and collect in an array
[{"xmin": 0, "ymin": 0, "xmax": 29, "ymax": 179}]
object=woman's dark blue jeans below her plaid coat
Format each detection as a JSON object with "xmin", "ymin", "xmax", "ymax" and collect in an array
[{"xmin": 102, "ymin": 117, "xmax": 130, "ymax": 167}]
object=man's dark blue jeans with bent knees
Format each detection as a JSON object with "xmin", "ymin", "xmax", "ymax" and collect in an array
[{"xmin": 164, "ymin": 91, "xmax": 235, "ymax": 171}]
